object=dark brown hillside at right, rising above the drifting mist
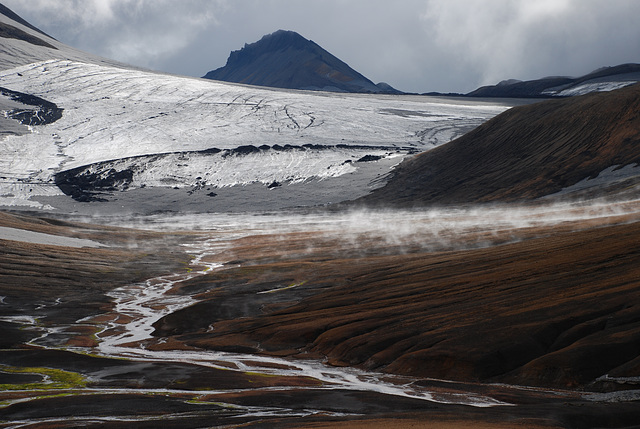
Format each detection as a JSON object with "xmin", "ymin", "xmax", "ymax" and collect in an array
[{"xmin": 363, "ymin": 85, "xmax": 640, "ymax": 206}]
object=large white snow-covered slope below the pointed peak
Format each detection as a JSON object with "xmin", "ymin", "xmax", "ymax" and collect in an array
[{"xmin": 0, "ymin": 60, "xmax": 508, "ymax": 209}]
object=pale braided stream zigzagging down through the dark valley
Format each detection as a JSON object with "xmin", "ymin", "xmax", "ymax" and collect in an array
[{"xmin": 89, "ymin": 229, "xmax": 509, "ymax": 407}]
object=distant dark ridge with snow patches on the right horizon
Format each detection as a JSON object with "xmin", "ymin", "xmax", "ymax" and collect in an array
[{"xmin": 466, "ymin": 64, "xmax": 640, "ymax": 98}]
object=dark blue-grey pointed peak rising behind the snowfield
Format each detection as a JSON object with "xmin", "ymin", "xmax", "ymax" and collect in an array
[{"xmin": 204, "ymin": 30, "xmax": 399, "ymax": 93}]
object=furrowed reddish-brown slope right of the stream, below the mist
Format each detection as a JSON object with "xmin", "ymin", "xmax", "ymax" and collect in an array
[{"xmin": 151, "ymin": 206, "xmax": 640, "ymax": 387}]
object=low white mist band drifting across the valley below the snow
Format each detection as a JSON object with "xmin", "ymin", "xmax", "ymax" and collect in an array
[{"xmin": 83, "ymin": 200, "xmax": 640, "ymax": 255}]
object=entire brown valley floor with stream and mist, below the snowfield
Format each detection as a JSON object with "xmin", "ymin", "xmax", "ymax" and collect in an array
[{"xmin": 0, "ymin": 201, "xmax": 640, "ymax": 428}]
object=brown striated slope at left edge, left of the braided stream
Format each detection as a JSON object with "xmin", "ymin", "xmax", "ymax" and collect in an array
[{"xmin": 0, "ymin": 212, "xmax": 188, "ymax": 338}]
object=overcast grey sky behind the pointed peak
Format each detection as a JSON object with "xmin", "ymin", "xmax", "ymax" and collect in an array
[{"xmin": 5, "ymin": 0, "xmax": 640, "ymax": 92}]
